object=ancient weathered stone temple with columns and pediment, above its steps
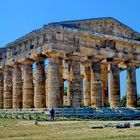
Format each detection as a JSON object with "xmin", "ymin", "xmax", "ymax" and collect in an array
[{"xmin": 0, "ymin": 18, "xmax": 140, "ymax": 109}]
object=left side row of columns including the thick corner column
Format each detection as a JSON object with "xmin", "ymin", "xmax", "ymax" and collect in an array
[{"xmin": 0, "ymin": 57, "xmax": 64, "ymax": 109}]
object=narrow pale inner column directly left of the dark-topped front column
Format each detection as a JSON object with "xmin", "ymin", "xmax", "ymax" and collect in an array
[{"xmin": 84, "ymin": 66, "xmax": 91, "ymax": 106}]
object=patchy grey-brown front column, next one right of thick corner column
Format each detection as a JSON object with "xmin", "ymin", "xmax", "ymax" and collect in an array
[{"xmin": 70, "ymin": 59, "xmax": 81, "ymax": 107}]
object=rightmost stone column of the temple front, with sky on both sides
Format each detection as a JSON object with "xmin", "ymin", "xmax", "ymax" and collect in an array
[{"xmin": 127, "ymin": 66, "xmax": 137, "ymax": 108}]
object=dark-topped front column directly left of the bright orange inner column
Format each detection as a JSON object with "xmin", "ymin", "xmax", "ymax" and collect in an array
[{"xmin": 91, "ymin": 62, "xmax": 102, "ymax": 108}]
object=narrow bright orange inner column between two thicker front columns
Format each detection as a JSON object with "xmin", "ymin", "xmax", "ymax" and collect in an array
[{"xmin": 101, "ymin": 63, "xmax": 108, "ymax": 107}]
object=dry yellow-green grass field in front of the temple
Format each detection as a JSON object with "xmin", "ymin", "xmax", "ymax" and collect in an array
[{"xmin": 0, "ymin": 119, "xmax": 140, "ymax": 140}]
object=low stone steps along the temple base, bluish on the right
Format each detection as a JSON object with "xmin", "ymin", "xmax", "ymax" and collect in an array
[{"xmin": 0, "ymin": 107, "xmax": 140, "ymax": 121}]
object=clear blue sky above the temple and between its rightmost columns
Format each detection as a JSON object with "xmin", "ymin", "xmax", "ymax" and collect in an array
[{"xmin": 0, "ymin": 0, "xmax": 140, "ymax": 94}]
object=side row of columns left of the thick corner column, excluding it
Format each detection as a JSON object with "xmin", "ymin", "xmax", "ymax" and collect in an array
[{"xmin": 0, "ymin": 62, "xmax": 46, "ymax": 109}]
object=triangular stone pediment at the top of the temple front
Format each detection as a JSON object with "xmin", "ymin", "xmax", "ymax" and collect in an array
[{"xmin": 52, "ymin": 17, "xmax": 140, "ymax": 40}]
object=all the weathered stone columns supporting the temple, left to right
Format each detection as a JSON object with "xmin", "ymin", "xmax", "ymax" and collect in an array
[{"xmin": 0, "ymin": 57, "xmax": 137, "ymax": 109}]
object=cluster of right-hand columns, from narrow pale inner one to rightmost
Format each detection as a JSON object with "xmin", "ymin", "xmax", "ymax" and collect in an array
[{"xmin": 84, "ymin": 62, "xmax": 137, "ymax": 108}]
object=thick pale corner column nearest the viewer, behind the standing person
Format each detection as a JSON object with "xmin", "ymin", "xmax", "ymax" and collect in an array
[{"xmin": 48, "ymin": 57, "xmax": 60, "ymax": 108}]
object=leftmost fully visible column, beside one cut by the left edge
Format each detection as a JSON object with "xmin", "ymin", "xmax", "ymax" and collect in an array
[{"xmin": 3, "ymin": 67, "xmax": 13, "ymax": 109}]
